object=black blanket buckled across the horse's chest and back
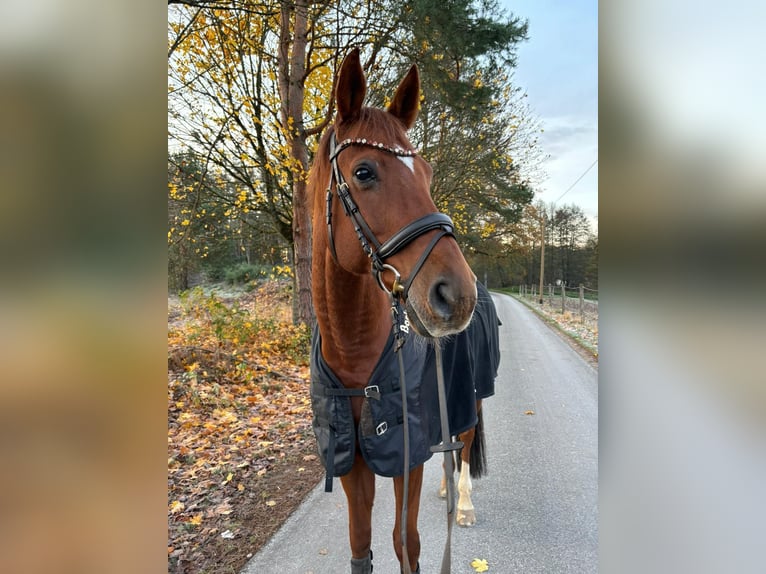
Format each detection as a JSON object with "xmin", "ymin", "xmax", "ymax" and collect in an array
[{"xmin": 311, "ymin": 282, "xmax": 500, "ymax": 490}]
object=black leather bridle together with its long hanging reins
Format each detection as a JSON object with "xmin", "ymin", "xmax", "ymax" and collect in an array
[{"xmin": 325, "ymin": 133, "xmax": 463, "ymax": 574}]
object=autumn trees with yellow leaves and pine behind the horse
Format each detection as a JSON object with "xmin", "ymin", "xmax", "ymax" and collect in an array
[{"xmin": 168, "ymin": 0, "xmax": 598, "ymax": 324}]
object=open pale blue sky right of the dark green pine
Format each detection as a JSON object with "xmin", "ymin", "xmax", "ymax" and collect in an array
[{"xmin": 499, "ymin": 0, "xmax": 598, "ymax": 231}]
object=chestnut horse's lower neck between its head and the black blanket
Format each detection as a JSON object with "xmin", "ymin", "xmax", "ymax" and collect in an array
[{"xmin": 313, "ymin": 251, "xmax": 391, "ymax": 388}]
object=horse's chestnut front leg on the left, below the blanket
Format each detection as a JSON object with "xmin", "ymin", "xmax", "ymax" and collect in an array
[{"xmin": 340, "ymin": 453, "xmax": 375, "ymax": 574}]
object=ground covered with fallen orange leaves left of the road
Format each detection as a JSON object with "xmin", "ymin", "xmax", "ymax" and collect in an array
[{"xmin": 168, "ymin": 280, "xmax": 319, "ymax": 572}]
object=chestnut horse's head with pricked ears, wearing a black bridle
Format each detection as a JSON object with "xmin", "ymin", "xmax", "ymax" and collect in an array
[{"xmin": 313, "ymin": 50, "xmax": 476, "ymax": 337}]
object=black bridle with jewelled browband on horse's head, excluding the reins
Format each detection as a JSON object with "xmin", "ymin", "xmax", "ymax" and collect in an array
[{"xmin": 326, "ymin": 133, "xmax": 455, "ymax": 299}]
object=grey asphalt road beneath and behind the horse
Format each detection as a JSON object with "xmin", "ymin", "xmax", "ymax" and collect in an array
[{"xmin": 242, "ymin": 294, "xmax": 598, "ymax": 574}]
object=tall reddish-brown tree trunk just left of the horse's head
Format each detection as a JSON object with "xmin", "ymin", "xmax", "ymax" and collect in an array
[{"xmin": 279, "ymin": 0, "xmax": 315, "ymax": 327}]
